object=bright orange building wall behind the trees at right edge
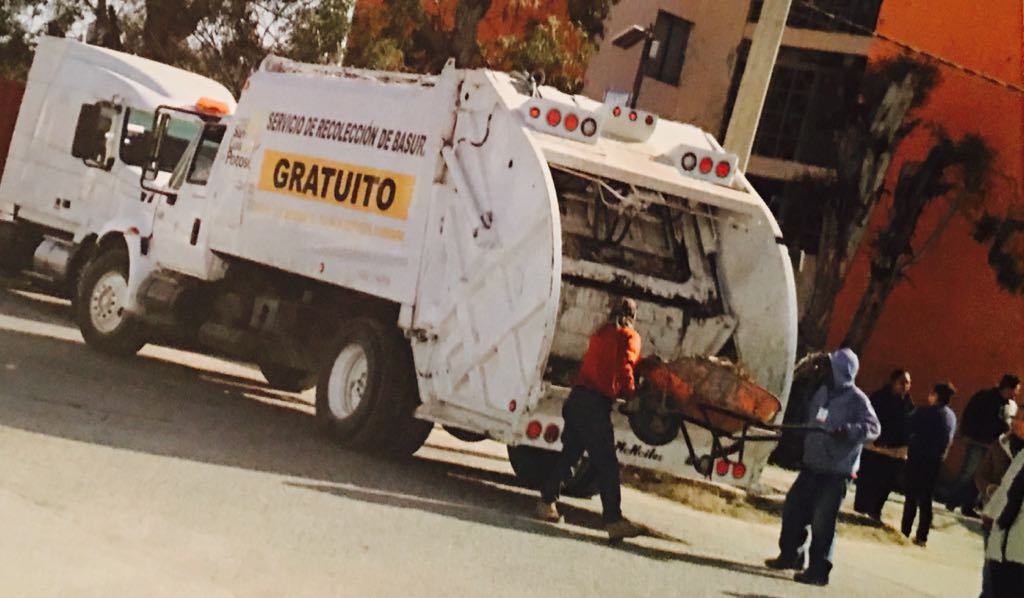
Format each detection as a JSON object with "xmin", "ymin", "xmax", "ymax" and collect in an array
[{"xmin": 829, "ymin": 0, "xmax": 1024, "ymax": 444}]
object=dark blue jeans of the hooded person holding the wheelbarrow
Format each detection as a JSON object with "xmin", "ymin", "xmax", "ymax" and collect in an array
[{"xmin": 778, "ymin": 469, "xmax": 850, "ymax": 576}]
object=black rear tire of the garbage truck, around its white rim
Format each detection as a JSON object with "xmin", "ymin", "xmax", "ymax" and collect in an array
[{"xmin": 316, "ymin": 317, "xmax": 433, "ymax": 457}]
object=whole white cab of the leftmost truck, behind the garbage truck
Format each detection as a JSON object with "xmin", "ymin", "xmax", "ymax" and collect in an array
[{"xmin": 0, "ymin": 37, "xmax": 234, "ymax": 289}]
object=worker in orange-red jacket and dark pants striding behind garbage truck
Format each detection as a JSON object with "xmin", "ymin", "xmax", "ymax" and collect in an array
[{"xmin": 537, "ymin": 299, "xmax": 642, "ymax": 542}]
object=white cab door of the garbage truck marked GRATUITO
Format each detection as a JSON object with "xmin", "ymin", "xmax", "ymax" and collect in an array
[{"xmin": 150, "ymin": 121, "xmax": 225, "ymax": 279}]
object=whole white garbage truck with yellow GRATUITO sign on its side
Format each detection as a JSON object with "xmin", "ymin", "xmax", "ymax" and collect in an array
[{"xmin": 2, "ymin": 43, "xmax": 797, "ymax": 488}]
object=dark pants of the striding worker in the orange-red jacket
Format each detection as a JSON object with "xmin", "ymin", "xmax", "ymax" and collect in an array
[{"xmin": 541, "ymin": 386, "xmax": 623, "ymax": 523}]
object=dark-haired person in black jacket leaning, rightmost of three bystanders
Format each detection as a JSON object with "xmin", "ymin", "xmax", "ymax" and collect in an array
[{"xmin": 946, "ymin": 374, "xmax": 1021, "ymax": 517}]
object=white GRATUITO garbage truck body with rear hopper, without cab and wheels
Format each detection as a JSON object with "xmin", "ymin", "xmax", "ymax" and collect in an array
[{"xmin": 142, "ymin": 57, "xmax": 797, "ymax": 484}]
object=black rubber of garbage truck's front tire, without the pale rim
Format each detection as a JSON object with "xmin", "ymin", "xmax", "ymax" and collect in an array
[{"xmin": 74, "ymin": 250, "xmax": 145, "ymax": 356}]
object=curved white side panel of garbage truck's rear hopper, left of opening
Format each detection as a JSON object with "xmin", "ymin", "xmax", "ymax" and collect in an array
[{"xmin": 413, "ymin": 102, "xmax": 562, "ymax": 430}]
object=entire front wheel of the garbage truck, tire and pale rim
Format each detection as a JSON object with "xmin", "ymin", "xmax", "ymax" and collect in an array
[{"xmin": 74, "ymin": 250, "xmax": 145, "ymax": 356}]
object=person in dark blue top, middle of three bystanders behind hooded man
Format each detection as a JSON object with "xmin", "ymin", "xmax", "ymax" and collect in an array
[{"xmin": 901, "ymin": 382, "xmax": 956, "ymax": 546}]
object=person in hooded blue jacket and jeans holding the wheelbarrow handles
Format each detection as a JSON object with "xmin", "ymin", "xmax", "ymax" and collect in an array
[{"xmin": 765, "ymin": 349, "xmax": 881, "ymax": 586}]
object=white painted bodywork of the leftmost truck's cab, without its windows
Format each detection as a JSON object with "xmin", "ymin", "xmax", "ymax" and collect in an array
[{"xmin": 0, "ymin": 37, "xmax": 234, "ymax": 241}]
